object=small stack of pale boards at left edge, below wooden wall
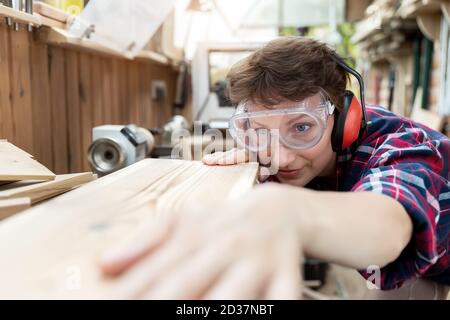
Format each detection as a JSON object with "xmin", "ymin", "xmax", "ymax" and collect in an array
[{"xmin": 0, "ymin": 140, "xmax": 96, "ymax": 220}]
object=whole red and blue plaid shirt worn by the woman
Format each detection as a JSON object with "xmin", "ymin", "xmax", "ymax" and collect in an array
[{"xmin": 337, "ymin": 106, "xmax": 450, "ymax": 289}]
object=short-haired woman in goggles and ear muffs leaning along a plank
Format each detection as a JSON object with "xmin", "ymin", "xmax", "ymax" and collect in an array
[{"xmin": 102, "ymin": 37, "xmax": 450, "ymax": 299}]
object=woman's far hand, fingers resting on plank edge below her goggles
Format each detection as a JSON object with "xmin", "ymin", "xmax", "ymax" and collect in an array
[{"xmin": 202, "ymin": 148, "xmax": 270, "ymax": 182}]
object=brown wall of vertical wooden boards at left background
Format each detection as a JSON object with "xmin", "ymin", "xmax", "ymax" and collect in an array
[{"xmin": 0, "ymin": 22, "xmax": 176, "ymax": 174}]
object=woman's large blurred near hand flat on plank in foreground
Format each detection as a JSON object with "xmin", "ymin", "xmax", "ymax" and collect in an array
[{"xmin": 101, "ymin": 183, "xmax": 302, "ymax": 299}]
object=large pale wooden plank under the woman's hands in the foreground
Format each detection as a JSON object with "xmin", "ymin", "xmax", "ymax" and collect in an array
[{"xmin": 0, "ymin": 159, "xmax": 257, "ymax": 299}]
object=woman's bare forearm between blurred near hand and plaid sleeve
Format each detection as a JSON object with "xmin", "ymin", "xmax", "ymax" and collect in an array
[{"xmin": 290, "ymin": 188, "xmax": 412, "ymax": 269}]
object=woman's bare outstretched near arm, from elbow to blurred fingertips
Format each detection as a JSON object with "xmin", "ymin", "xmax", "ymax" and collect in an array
[{"xmin": 101, "ymin": 183, "xmax": 412, "ymax": 299}]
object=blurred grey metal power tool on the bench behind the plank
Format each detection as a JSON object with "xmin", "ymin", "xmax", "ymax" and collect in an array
[{"xmin": 88, "ymin": 115, "xmax": 188, "ymax": 176}]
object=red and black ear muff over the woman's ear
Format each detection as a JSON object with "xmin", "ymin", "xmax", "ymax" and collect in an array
[{"xmin": 331, "ymin": 91, "xmax": 363, "ymax": 152}]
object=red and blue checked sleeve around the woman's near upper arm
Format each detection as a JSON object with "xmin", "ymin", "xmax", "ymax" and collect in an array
[{"xmin": 351, "ymin": 129, "xmax": 450, "ymax": 290}]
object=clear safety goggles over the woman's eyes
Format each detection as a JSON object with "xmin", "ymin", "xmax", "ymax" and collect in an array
[{"xmin": 229, "ymin": 95, "xmax": 335, "ymax": 152}]
